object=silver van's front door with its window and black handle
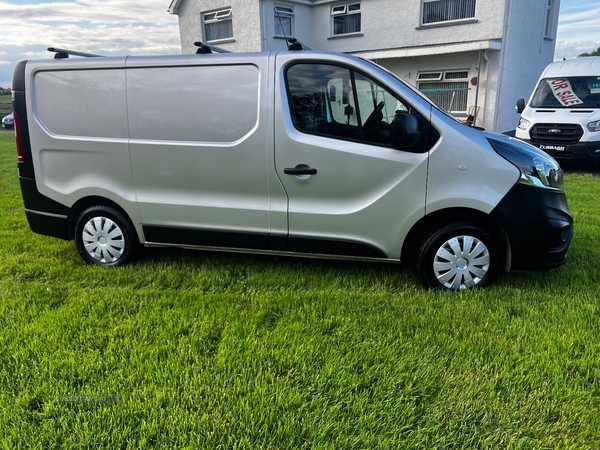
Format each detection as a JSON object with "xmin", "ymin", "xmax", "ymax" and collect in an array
[{"xmin": 275, "ymin": 54, "xmax": 428, "ymax": 259}]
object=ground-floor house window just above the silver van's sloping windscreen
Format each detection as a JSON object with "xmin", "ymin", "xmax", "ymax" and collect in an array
[{"xmin": 417, "ymin": 70, "xmax": 469, "ymax": 114}]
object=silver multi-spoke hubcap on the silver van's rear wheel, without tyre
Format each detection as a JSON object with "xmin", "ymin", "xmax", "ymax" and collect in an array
[{"xmin": 81, "ymin": 217, "xmax": 125, "ymax": 264}]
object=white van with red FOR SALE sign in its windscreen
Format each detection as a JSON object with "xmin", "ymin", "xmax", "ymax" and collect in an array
[{"xmin": 515, "ymin": 57, "xmax": 600, "ymax": 169}]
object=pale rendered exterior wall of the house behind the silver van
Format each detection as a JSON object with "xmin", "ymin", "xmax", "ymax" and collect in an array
[{"xmin": 171, "ymin": 0, "xmax": 560, "ymax": 132}]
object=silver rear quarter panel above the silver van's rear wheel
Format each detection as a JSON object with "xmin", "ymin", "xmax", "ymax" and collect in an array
[{"xmin": 26, "ymin": 58, "xmax": 138, "ymax": 223}]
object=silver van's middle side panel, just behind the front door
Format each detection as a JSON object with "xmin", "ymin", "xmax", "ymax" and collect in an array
[{"xmin": 127, "ymin": 55, "xmax": 269, "ymax": 249}]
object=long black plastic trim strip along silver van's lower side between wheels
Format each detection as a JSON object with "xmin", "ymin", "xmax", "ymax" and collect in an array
[{"xmin": 142, "ymin": 225, "xmax": 387, "ymax": 258}]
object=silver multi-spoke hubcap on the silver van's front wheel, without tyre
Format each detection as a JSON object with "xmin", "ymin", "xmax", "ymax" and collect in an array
[{"xmin": 433, "ymin": 236, "xmax": 490, "ymax": 289}]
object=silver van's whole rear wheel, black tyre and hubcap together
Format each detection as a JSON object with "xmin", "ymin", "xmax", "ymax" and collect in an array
[{"xmin": 75, "ymin": 206, "xmax": 140, "ymax": 266}]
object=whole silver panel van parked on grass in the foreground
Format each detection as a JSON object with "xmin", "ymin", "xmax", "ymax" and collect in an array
[{"xmin": 13, "ymin": 47, "xmax": 573, "ymax": 290}]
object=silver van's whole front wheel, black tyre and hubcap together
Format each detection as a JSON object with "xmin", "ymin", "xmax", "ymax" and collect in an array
[{"xmin": 415, "ymin": 222, "xmax": 500, "ymax": 291}]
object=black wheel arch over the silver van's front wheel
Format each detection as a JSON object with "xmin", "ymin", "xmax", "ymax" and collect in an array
[{"xmin": 400, "ymin": 208, "xmax": 511, "ymax": 272}]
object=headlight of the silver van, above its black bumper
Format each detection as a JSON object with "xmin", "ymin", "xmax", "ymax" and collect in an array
[{"xmin": 486, "ymin": 136, "xmax": 564, "ymax": 191}]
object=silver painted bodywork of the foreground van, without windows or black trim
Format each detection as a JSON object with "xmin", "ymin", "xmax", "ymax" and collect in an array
[{"xmin": 26, "ymin": 52, "xmax": 519, "ymax": 261}]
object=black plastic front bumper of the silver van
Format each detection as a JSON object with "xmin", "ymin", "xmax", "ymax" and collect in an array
[{"xmin": 491, "ymin": 184, "xmax": 573, "ymax": 270}]
